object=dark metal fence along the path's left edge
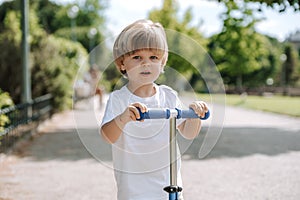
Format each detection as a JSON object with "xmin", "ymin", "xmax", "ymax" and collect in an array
[{"xmin": 0, "ymin": 94, "xmax": 52, "ymax": 152}]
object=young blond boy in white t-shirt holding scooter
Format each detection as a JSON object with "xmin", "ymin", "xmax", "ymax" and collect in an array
[{"xmin": 100, "ymin": 20, "xmax": 208, "ymax": 200}]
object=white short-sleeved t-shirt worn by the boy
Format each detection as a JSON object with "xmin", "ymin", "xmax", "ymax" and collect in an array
[{"xmin": 102, "ymin": 85, "xmax": 182, "ymax": 200}]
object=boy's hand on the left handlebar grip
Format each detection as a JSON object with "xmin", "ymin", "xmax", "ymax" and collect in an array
[{"xmin": 119, "ymin": 102, "xmax": 148, "ymax": 124}]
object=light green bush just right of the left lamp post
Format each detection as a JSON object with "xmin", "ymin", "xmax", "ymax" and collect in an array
[{"xmin": 32, "ymin": 36, "xmax": 87, "ymax": 110}]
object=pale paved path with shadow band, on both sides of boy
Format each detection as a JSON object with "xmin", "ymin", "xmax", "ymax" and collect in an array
[{"xmin": 0, "ymin": 96, "xmax": 300, "ymax": 200}]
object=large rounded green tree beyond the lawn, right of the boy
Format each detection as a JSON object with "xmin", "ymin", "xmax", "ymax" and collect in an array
[{"xmin": 209, "ymin": 0, "xmax": 270, "ymax": 92}]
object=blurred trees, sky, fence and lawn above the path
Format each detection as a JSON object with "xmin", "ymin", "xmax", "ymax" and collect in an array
[{"xmin": 0, "ymin": 0, "xmax": 300, "ymax": 145}]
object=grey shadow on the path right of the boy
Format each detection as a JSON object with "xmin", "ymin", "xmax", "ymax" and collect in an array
[{"xmin": 184, "ymin": 127, "xmax": 300, "ymax": 159}]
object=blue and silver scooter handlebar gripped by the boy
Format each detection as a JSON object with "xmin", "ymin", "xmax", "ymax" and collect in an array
[{"xmin": 138, "ymin": 108, "xmax": 210, "ymax": 121}]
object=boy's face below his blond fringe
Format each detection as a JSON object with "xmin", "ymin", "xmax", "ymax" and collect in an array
[{"xmin": 120, "ymin": 49, "xmax": 164, "ymax": 84}]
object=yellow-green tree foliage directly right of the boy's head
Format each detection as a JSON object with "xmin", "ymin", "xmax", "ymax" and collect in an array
[{"xmin": 149, "ymin": 0, "xmax": 208, "ymax": 90}]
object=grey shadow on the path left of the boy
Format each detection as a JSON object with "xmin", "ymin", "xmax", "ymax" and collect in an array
[{"xmin": 16, "ymin": 129, "xmax": 112, "ymax": 161}]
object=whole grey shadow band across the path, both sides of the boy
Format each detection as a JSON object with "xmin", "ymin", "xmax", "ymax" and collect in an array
[{"xmin": 15, "ymin": 127, "xmax": 300, "ymax": 161}]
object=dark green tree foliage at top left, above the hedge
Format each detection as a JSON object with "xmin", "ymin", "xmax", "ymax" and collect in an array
[{"xmin": 35, "ymin": 0, "xmax": 105, "ymax": 51}]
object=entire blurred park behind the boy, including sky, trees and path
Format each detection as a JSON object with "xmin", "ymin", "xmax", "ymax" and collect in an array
[{"xmin": 0, "ymin": 0, "xmax": 300, "ymax": 200}]
